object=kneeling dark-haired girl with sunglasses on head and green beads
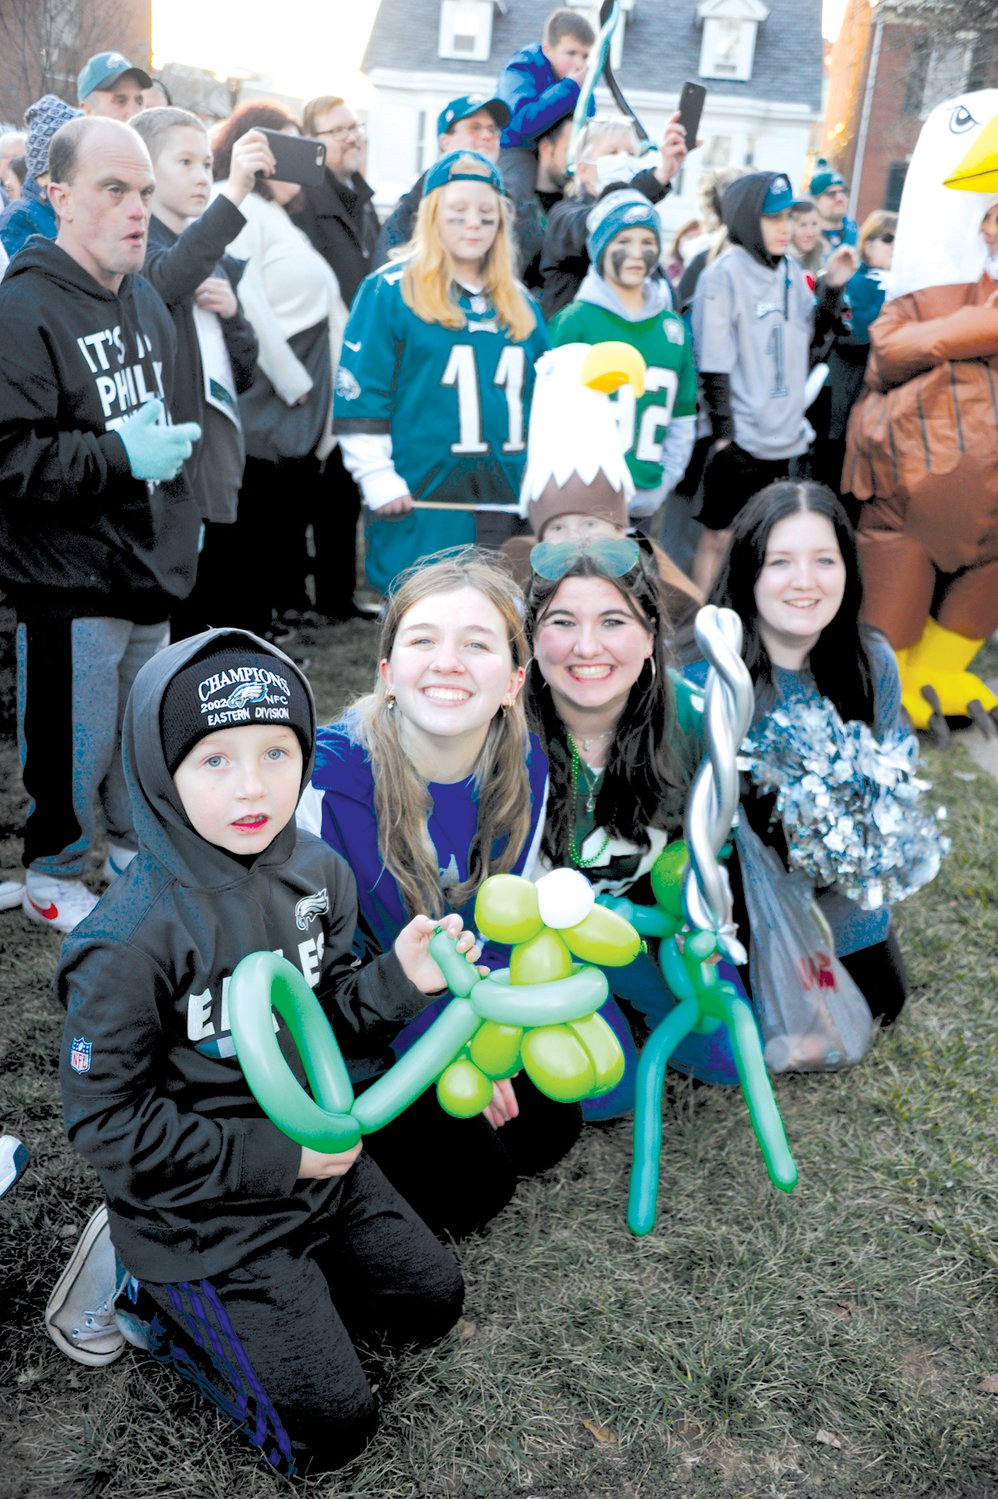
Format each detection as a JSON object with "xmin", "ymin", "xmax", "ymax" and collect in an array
[{"xmin": 527, "ymin": 535, "xmax": 736, "ymax": 1097}]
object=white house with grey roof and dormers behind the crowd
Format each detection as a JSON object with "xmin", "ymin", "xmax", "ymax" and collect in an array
[{"xmin": 363, "ymin": 0, "xmax": 823, "ymax": 229}]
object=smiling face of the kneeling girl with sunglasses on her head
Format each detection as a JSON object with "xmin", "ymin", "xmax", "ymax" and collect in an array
[{"xmin": 533, "ymin": 577, "xmax": 655, "ymax": 721}]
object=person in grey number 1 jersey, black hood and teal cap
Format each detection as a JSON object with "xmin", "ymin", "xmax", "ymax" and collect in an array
[{"xmin": 692, "ymin": 172, "xmax": 857, "ymax": 581}]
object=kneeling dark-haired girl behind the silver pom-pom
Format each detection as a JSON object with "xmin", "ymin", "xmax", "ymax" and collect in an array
[{"xmin": 685, "ymin": 480, "xmax": 908, "ymax": 1025}]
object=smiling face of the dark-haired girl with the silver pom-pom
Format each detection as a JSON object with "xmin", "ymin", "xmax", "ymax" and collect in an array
[{"xmin": 755, "ymin": 510, "xmax": 845, "ymax": 670}]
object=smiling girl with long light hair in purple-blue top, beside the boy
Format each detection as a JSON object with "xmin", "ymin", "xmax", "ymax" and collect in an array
[{"xmin": 298, "ymin": 547, "xmax": 581, "ymax": 1237}]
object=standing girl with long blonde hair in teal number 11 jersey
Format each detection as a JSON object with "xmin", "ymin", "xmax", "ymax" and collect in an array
[{"xmin": 334, "ymin": 151, "xmax": 548, "ymax": 592}]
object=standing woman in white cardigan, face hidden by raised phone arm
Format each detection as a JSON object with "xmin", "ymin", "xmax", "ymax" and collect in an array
[{"xmin": 213, "ymin": 100, "xmax": 346, "ymax": 639}]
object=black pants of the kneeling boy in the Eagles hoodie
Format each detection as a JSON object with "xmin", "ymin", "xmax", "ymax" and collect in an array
[{"xmin": 142, "ymin": 1151, "xmax": 465, "ymax": 1474}]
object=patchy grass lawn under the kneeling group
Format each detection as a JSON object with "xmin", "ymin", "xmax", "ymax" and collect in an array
[{"xmin": 0, "ymin": 615, "xmax": 998, "ymax": 1499}]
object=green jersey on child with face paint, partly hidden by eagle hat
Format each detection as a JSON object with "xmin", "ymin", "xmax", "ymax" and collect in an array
[{"xmin": 550, "ymin": 301, "xmax": 697, "ymax": 489}]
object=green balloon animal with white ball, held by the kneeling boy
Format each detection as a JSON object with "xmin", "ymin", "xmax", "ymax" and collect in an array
[{"xmin": 229, "ymin": 869, "xmax": 641, "ymax": 1153}]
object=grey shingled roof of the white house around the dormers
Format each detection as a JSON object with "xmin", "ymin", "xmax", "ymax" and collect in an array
[{"xmin": 363, "ymin": 0, "xmax": 823, "ymax": 109}]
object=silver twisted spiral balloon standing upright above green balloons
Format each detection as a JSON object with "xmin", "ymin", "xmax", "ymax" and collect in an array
[{"xmin": 683, "ymin": 604, "xmax": 755, "ymax": 964}]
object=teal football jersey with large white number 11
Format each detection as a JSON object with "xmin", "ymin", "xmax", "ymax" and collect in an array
[{"xmin": 334, "ymin": 262, "xmax": 550, "ymax": 508}]
